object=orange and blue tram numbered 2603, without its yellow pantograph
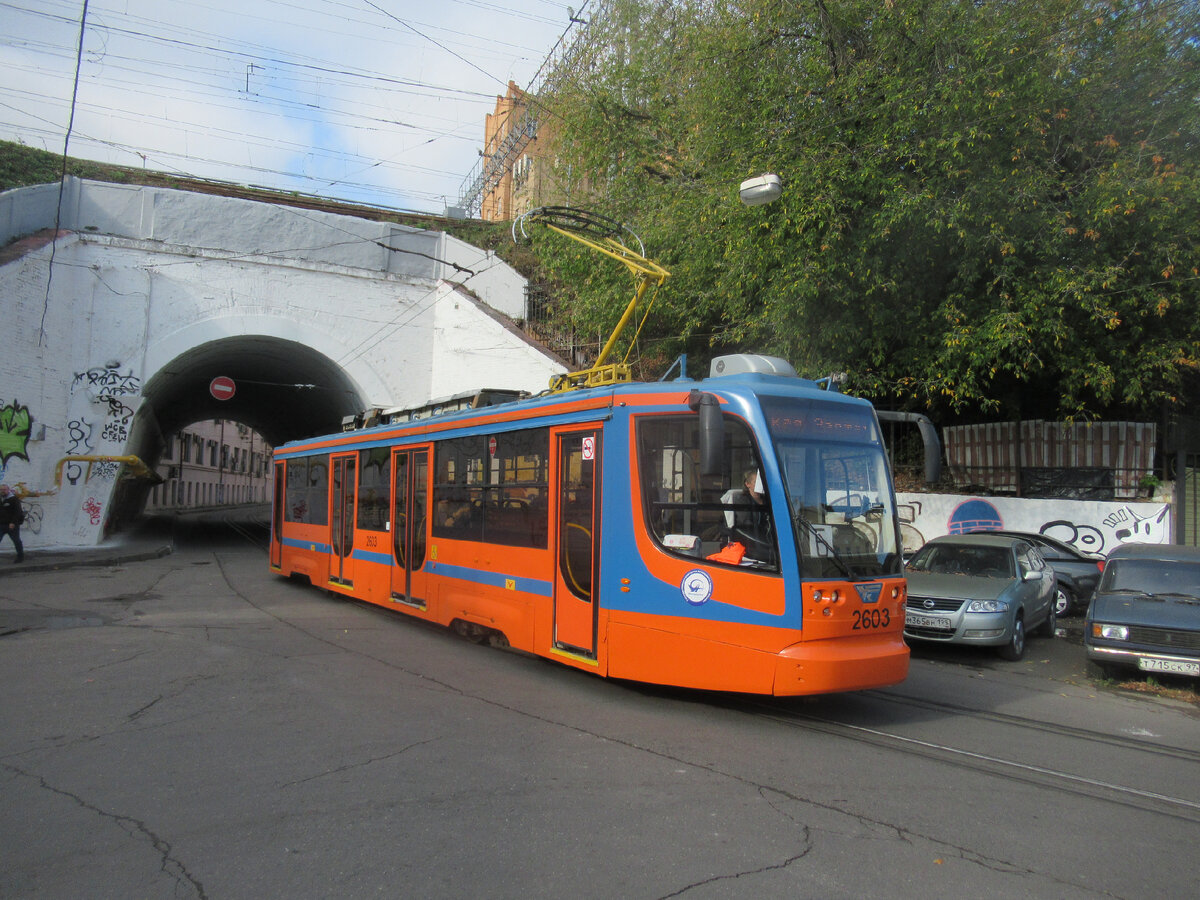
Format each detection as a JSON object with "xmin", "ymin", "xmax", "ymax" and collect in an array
[{"xmin": 270, "ymin": 355, "xmax": 908, "ymax": 695}]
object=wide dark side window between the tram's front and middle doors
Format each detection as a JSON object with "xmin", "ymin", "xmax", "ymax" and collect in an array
[{"xmin": 432, "ymin": 428, "xmax": 550, "ymax": 547}]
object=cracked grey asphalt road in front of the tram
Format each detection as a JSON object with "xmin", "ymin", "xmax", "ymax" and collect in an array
[{"xmin": 0, "ymin": 518, "xmax": 1200, "ymax": 899}]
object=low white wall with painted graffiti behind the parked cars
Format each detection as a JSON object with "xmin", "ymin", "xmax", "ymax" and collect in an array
[{"xmin": 896, "ymin": 493, "xmax": 1171, "ymax": 554}]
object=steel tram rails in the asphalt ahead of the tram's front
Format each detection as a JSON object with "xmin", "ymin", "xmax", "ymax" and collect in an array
[{"xmin": 737, "ymin": 691, "xmax": 1200, "ymax": 824}]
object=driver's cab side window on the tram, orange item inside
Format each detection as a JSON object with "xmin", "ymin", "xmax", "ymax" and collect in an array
[{"xmin": 637, "ymin": 415, "xmax": 779, "ymax": 570}]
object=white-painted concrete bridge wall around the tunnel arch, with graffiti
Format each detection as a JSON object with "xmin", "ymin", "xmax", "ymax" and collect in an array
[{"xmin": 0, "ymin": 179, "xmax": 563, "ymax": 548}]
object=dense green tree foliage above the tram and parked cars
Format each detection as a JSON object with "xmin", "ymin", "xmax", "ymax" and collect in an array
[{"xmin": 544, "ymin": 0, "xmax": 1200, "ymax": 418}]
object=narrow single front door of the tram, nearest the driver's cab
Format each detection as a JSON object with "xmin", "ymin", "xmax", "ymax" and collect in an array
[{"xmin": 554, "ymin": 428, "xmax": 600, "ymax": 655}]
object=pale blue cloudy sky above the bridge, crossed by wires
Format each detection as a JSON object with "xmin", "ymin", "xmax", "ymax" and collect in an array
[{"xmin": 0, "ymin": 0, "xmax": 589, "ymax": 215}]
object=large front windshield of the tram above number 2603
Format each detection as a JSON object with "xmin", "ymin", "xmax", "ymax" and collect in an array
[{"xmin": 761, "ymin": 396, "xmax": 901, "ymax": 578}]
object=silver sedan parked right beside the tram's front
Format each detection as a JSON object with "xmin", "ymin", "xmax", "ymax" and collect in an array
[{"xmin": 904, "ymin": 534, "xmax": 1057, "ymax": 660}]
